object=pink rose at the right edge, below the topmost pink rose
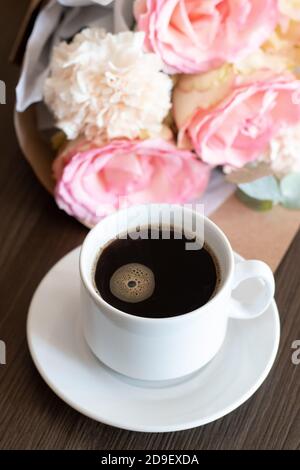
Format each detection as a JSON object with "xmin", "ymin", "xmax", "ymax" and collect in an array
[{"xmin": 174, "ymin": 73, "xmax": 300, "ymax": 168}]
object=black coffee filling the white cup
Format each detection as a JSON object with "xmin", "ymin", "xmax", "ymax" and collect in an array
[{"xmin": 95, "ymin": 228, "xmax": 219, "ymax": 318}]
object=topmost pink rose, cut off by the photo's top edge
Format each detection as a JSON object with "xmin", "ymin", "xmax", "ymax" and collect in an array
[{"xmin": 134, "ymin": 0, "xmax": 279, "ymax": 73}]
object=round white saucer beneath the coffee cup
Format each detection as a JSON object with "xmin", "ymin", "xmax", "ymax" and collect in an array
[{"xmin": 27, "ymin": 248, "xmax": 280, "ymax": 432}]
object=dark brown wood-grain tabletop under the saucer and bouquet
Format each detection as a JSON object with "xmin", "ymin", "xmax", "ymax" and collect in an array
[{"xmin": 0, "ymin": 0, "xmax": 300, "ymax": 450}]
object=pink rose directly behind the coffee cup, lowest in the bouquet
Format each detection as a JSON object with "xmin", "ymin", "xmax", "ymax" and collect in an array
[{"xmin": 54, "ymin": 140, "xmax": 210, "ymax": 226}]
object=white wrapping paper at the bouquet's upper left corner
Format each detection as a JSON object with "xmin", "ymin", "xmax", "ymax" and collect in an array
[{"xmin": 16, "ymin": 0, "xmax": 114, "ymax": 112}]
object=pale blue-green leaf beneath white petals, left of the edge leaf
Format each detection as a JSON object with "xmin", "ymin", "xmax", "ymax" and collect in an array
[{"xmin": 238, "ymin": 176, "xmax": 281, "ymax": 204}]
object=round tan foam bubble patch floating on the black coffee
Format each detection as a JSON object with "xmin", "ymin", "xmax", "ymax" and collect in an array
[{"xmin": 109, "ymin": 263, "xmax": 155, "ymax": 303}]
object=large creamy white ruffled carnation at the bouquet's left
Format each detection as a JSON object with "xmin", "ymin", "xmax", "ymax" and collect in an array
[{"xmin": 44, "ymin": 28, "xmax": 172, "ymax": 140}]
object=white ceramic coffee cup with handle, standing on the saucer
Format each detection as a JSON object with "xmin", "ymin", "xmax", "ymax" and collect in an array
[{"xmin": 80, "ymin": 204, "xmax": 274, "ymax": 380}]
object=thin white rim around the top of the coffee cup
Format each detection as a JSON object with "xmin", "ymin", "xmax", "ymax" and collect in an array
[{"xmin": 79, "ymin": 204, "xmax": 234, "ymax": 325}]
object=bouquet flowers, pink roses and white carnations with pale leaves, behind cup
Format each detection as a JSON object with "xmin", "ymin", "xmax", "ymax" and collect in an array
[{"xmin": 14, "ymin": 0, "xmax": 300, "ymax": 226}]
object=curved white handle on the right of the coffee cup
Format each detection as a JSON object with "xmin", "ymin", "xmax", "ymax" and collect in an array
[{"xmin": 229, "ymin": 260, "xmax": 275, "ymax": 320}]
